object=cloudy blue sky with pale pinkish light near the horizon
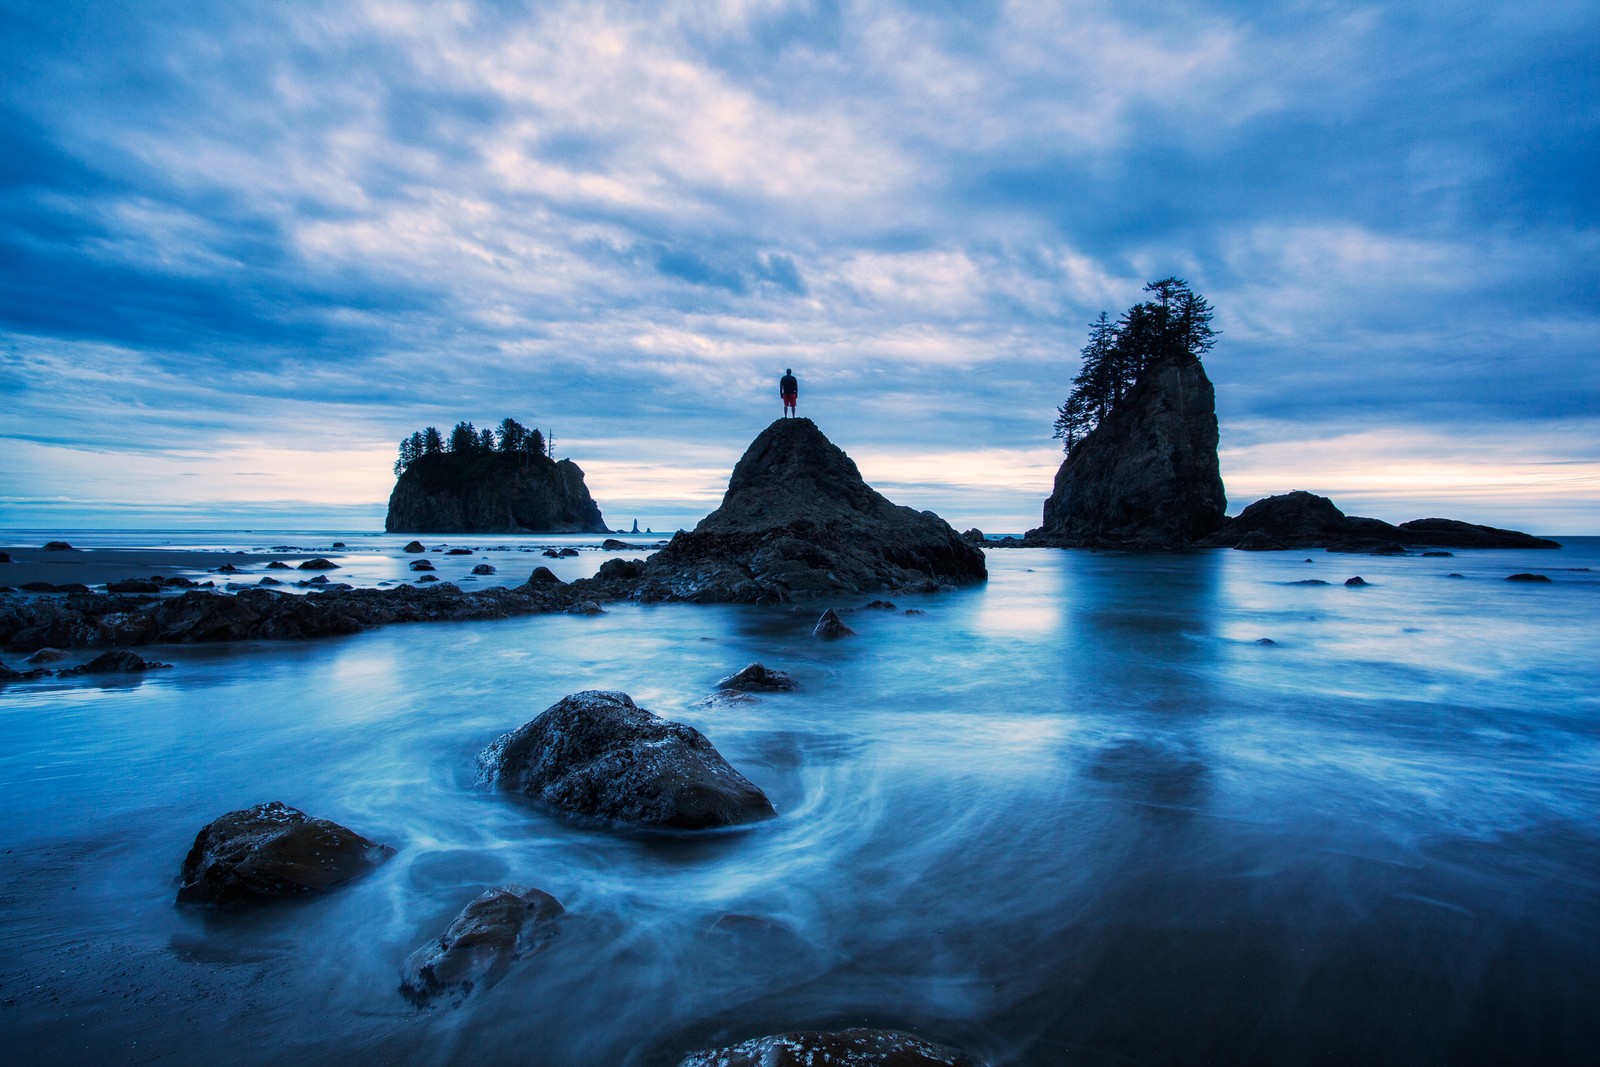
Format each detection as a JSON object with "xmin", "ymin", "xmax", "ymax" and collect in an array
[{"xmin": 0, "ymin": 0, "xmax": 1600, "ymax": 534}]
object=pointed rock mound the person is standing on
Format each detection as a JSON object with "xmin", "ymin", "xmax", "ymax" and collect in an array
[{"xmin": 638, "ymin": 419, "xmax": 987, "ymax": 603}]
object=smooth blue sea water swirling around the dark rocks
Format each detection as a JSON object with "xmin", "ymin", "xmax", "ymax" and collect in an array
[{"xmin": 0, "ymin": 533, "xmax": 1600, "ymax": 1067}]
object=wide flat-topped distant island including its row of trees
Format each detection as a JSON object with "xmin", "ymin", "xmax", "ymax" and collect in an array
[{"xmin": 384, "ymin": 419, "xmax": 610, "ymax": 533}]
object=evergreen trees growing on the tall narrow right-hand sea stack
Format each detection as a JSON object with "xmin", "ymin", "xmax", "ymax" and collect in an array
[{"xmin": 1054, "ymin": 278, "xmax": 1218, "ymax": 453}]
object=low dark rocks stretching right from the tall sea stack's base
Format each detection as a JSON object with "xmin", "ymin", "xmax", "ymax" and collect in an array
[{"xmin": 1205, "ymin": 490, "xmax": 1562, "ymax": 553}]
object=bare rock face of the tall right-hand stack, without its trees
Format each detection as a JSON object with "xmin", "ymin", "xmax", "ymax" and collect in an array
[{"xmin": 1027, "ymin": 357, "xmax": 1227, "ymax": 547}]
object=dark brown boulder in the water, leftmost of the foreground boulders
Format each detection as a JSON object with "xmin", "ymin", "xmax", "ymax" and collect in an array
[{"xmin": 178, "ymin": 801, "xmax": 395, "ymax": 904}]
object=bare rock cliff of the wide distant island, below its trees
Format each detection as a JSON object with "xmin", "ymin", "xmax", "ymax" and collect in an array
[{"xmin": 384, "ymin": 453, "xmax": 610, "ymax": 533}]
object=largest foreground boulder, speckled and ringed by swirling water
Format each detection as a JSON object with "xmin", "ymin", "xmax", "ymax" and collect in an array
[{"xmin": 478, "ymin": 689, "xmax": 774, "ymax": 830}]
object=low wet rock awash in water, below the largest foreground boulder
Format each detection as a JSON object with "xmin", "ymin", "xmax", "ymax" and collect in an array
[{"xmin": 400, "ymin": 885, "xmax": 565, "ymax": 1005}]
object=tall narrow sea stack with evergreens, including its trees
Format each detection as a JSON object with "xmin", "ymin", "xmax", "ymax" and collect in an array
[{"xmin": 1027, "ymin": 278, "xmax": 1227, "ymax": 547}]
